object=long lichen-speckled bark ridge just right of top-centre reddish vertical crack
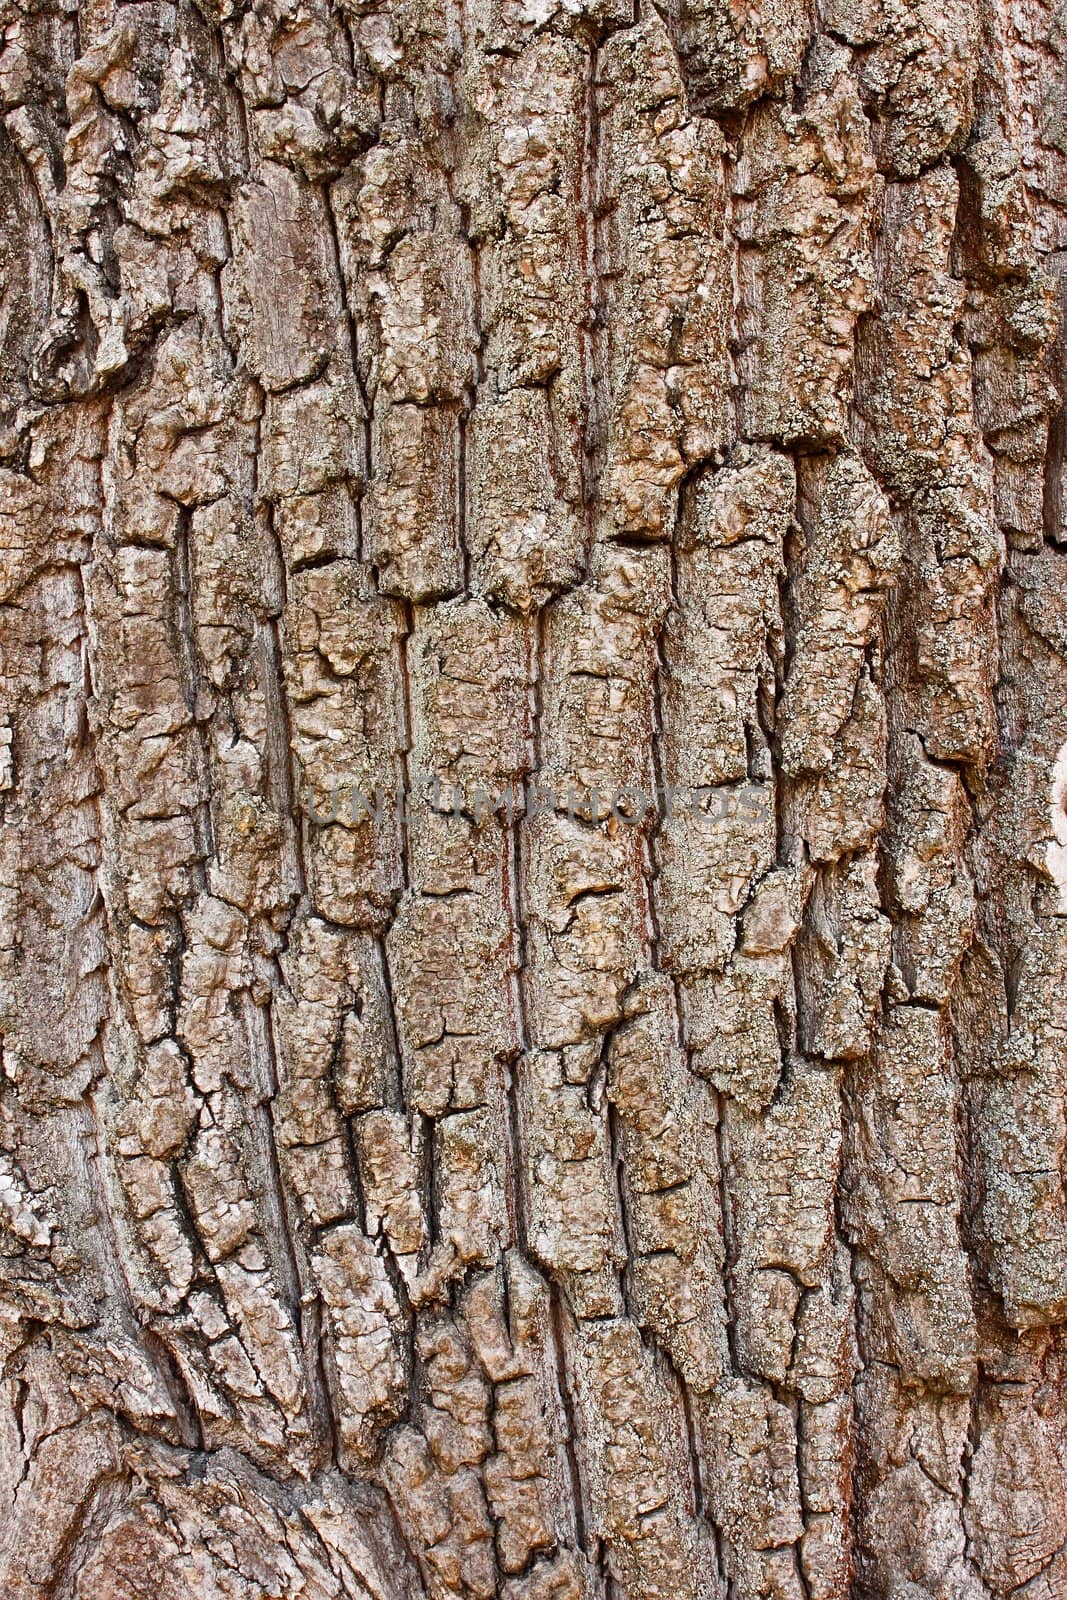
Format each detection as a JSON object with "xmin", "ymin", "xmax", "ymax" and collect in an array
[{"xmin": 597, "ymin": 16, "xmax": 729, "ymax": 539}]
